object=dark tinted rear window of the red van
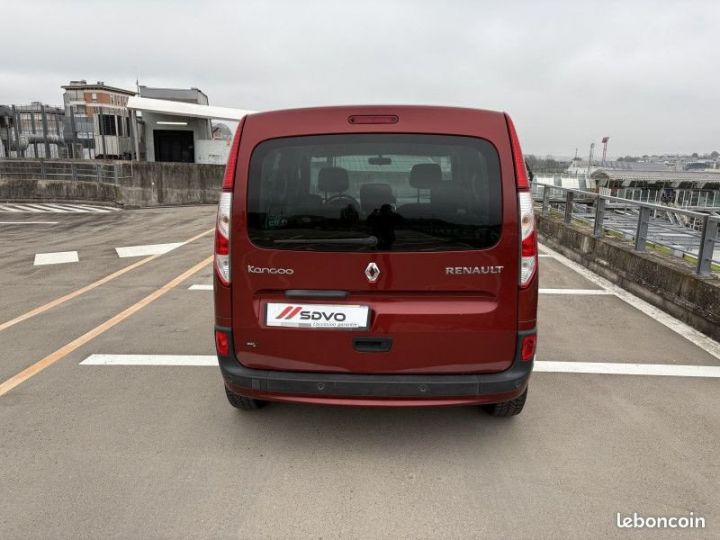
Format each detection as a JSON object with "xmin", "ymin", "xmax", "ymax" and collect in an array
[{"xmin": 248, "ymin": 134, "xmax": 502, "ymax": 251}]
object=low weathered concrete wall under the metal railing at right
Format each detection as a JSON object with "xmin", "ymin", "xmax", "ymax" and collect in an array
[{"xmin": 536, "ymin": 216, "xmax": 720, "ymax": 340}]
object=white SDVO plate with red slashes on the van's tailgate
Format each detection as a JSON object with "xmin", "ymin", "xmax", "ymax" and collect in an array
[{"xmin": 265, "ymin": 302, "xmax": 370, "ymax": 328}]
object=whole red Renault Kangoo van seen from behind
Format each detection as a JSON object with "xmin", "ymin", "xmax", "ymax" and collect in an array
[{"xmin": 214, "ymin": 106, "xmax": 538, "ymax": 416}]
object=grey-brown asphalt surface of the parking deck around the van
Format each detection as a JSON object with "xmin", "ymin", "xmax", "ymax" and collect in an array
[{"xmin": 0, "ymin": 206, "xmax": 720, "ymax": 539}]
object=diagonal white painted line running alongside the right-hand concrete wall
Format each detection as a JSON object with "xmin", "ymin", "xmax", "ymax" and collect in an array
[{"xmin": 543, "ymin": 246, "xmax": 720, "ymax": 360}]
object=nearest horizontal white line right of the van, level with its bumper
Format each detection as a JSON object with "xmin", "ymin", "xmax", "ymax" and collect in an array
[{"xmin": 533, "ymin": 361, "xmax": 720, "ymax": 379}]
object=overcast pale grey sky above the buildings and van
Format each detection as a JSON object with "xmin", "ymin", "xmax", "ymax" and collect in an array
[{"xmin": 0, "ymin": 0, "xmax": 720, "ymax": 156}]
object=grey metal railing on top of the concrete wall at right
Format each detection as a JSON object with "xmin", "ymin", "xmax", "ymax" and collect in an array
[{"xmin": 533, "ymin": 184, "xmax": 720, "ymax": 276}]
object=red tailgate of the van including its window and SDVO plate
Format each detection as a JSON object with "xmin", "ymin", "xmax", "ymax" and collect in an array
[{"xmin": 231, "ymin": 108, "xmax": 519, "ymax": 373}]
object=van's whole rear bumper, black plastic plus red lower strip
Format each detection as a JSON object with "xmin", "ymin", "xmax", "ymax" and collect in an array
[{"xmin": 217, "ymin": 327, "xmax": 535, "ymax": 405}]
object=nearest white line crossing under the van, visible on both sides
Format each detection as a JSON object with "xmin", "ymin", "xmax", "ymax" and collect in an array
[{"xmin": 80, "ymin": 354, "xmax": 720, "ymax": 378}]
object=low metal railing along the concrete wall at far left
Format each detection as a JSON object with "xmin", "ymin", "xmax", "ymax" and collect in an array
[{"xmin": 0, "ymin": 159, "xmax": 131, "ymax": 184}]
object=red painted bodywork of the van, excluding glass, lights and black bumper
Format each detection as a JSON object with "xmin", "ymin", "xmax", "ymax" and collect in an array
[{"xmin": 214, "ymin": 106, "xmax": 537, "ymax": 405}]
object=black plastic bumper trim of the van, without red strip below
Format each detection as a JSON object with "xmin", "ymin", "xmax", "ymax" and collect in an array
[{"xmin": 216, "ymin": 326, "xmax": 535, "ymax": 398}]
